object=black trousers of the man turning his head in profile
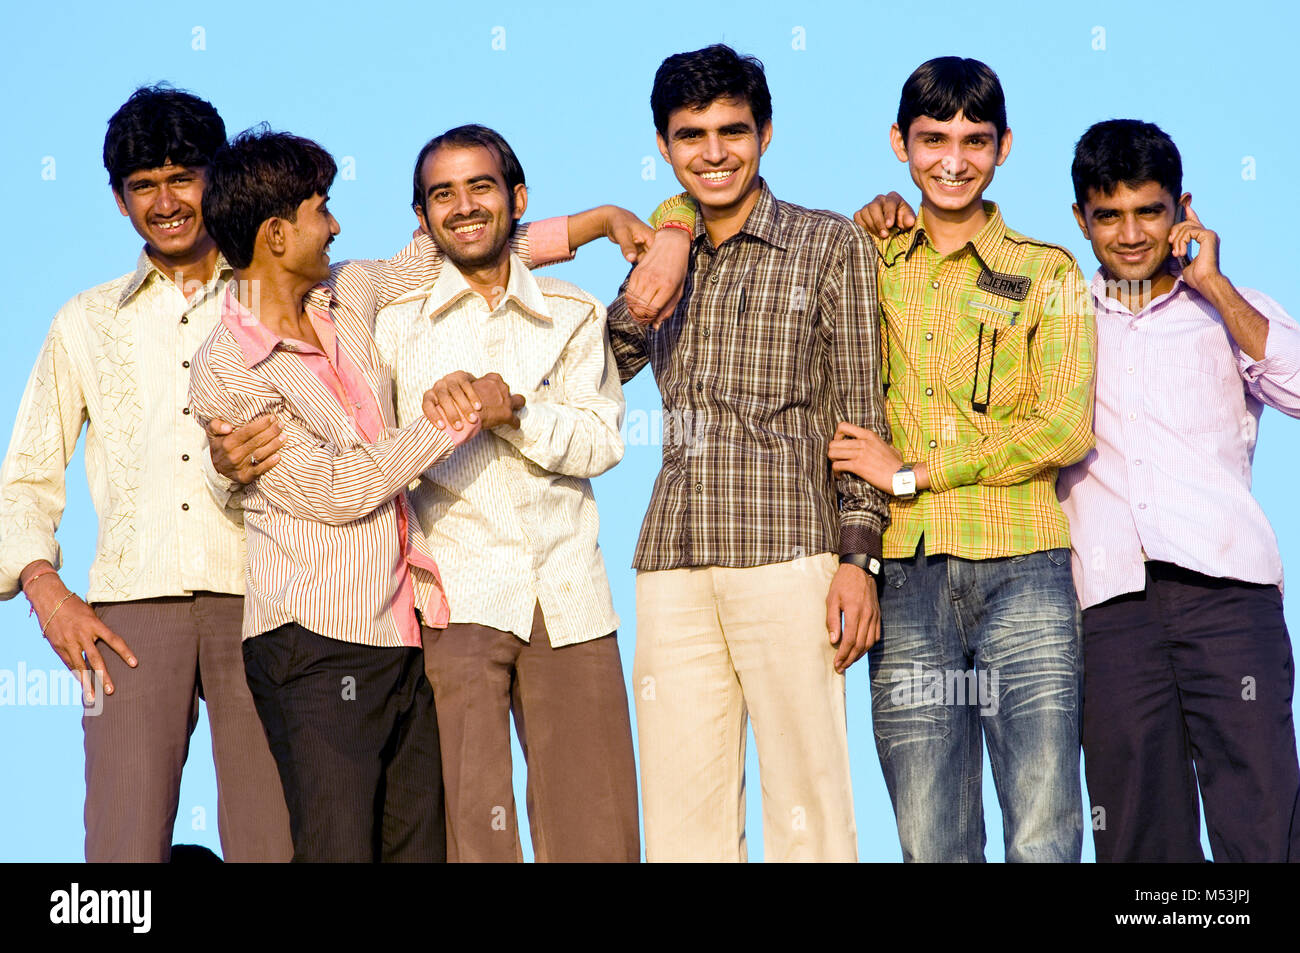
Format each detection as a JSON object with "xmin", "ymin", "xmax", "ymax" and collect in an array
[{"xmin": 243, "ymin": 624, "xmax": 447, "ymax": 862}]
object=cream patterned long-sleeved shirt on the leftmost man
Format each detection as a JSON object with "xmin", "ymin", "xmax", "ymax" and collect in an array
[{"xmin": 0, "ymin": 251, "xmax": 244, "ymax": 602}]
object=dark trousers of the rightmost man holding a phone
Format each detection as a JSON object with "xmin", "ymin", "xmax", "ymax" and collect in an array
[{"xmin": 1083, "ymin": 562, "xmax": 1300, "ymax": 862}]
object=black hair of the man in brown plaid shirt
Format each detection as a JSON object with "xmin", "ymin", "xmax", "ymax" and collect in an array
[{"xmin": 650, "ymin": 43, "xmax": 772, "ymax": 137}]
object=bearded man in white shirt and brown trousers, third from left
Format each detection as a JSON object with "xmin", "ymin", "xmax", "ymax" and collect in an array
[{"xmin": 376, "ymin": 126, "xmax": 640, "ymax": 861}]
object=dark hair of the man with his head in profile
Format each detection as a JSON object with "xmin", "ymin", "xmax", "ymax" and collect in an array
[{"xmin": 203, "ymin": 126, "xmax": 338, "ymax": 268}]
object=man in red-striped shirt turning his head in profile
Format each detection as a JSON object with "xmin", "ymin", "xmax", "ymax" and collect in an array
[{"xmin": 190, "ymin": 133, "xmax": 517, "ymax": 861}]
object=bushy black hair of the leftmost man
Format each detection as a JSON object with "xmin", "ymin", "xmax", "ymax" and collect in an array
[{"xmin": 104, "ymin": 85, "xmax": 226, "ymax": 194}]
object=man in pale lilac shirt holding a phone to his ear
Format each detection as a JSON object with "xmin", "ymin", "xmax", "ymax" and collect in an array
[{"xmin": 1057, "ymin": 120, "xmax": 1300, "ymax": 862}]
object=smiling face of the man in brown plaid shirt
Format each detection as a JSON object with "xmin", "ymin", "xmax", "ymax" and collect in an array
[{"xmin": 658, "ymin": 99, "xmax": 772, "ymax": 218}]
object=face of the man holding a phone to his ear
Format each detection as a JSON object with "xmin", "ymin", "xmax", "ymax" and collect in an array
[{"xmin": 1074, "ymin": 182, "xmax": 1191, "ymax": 281}]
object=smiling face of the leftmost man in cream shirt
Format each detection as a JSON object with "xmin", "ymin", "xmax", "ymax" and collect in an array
[{"xmin": 113, "ymin": 161, "xmax": 208, "ymax": 265}]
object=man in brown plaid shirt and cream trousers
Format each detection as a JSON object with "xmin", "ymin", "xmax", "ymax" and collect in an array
[{"xmin": 608, "ymin": 46, "xmax": 889, "ymax": 861}]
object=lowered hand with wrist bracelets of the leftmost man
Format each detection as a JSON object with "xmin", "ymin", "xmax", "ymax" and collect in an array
[{"xmin": 23, "ymin": 560, "xmax": 139, "ymax": 705}]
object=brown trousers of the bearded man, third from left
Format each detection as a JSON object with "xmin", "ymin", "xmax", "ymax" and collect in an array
[{"xmin": 424, "ymin": 606, "xmax": 641, "ymax": 863}]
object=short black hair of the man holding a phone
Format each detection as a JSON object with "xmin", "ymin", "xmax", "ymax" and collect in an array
[{"xmin": 1070, "ymin": 120, "xmax": 1183, "ymax": 212}]
